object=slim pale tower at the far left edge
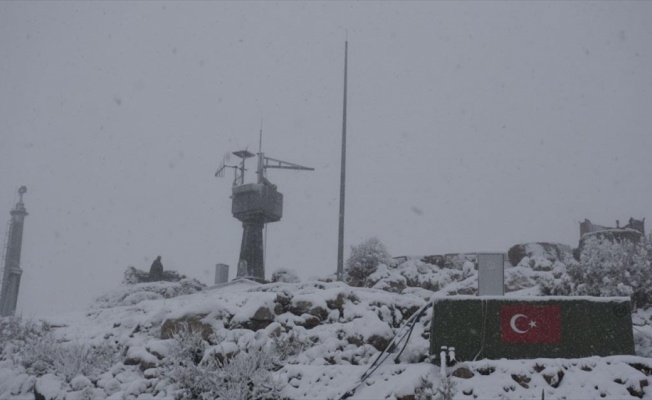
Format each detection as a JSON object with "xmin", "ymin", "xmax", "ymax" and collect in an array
[{"xmin": 0, "ymin": 186, "xmax": 27, "ymax": 317}]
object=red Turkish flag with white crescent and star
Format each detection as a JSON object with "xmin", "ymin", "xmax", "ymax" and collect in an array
[{"xmin": 500, "ymin": 304, "xmax": 561, "ymax": 344}]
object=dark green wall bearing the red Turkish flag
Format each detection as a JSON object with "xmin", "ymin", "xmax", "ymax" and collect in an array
[{"xmin": 430, "ymin": 297, "xmax": 634, "ymax": 361}]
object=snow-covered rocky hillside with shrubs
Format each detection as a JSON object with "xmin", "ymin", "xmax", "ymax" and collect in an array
[{"xmin": 0, "ymin": 254, "xmax": 652, "ymax": 400}]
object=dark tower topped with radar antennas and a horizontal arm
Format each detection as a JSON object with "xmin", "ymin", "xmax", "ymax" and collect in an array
[{"xmin": 215, "ymin": 129, "xmax": 314, "ymax": 283}]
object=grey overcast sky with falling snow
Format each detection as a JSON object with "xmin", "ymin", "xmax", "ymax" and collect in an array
[{"xmin": 0, "ymin": 1, "xmax": 652, "ymax": 316}]
